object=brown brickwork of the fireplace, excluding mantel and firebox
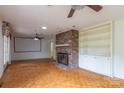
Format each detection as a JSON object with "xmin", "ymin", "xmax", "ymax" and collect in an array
[{"xmin": 56, "ymin": 30, "xmax": 79, "ymax": 68}]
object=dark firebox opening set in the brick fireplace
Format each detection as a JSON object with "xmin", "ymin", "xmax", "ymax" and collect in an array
[{"xmin": 57, "ymin": 53, "xmax": 68, "ymax": 65}]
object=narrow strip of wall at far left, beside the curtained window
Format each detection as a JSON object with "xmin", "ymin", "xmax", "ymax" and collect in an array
[{"xmin": 0, "ymin": 22, "xmax": 4, "ymax": 78}]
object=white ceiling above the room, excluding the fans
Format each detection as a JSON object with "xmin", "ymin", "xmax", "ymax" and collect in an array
[{"xmin": 0, "ymin": 5, "xmax": 124, "ymax": 35}]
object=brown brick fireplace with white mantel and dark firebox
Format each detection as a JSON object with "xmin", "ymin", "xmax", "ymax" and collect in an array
[{"xmin": 56, "ymin": 30, "xmax": 79, "ymax": 68}]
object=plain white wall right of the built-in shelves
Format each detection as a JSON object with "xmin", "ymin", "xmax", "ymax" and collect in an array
[{"xmin": 113, "ymin": 20, "xmax": 124, "ymax": 79}]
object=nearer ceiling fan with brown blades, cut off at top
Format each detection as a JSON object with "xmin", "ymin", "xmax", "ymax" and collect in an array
[{"xmin": 67, "ymin": 5, "xmax": 103, "ymax": 18}]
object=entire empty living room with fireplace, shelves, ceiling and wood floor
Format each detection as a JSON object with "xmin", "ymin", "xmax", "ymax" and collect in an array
[{"xmin": 0, "ymin": 5, "xmax": 124, "ymax": 88}]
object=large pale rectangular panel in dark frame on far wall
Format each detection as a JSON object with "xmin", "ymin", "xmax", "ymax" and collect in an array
[{"xmin": 14, "ymin": 37, "xmax": 41, "ymax": 52}]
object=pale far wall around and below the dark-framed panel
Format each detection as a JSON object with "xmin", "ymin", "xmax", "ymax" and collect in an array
[{"xmin": 11, "ymin": 39, "xmax": 51, "ymax": 60}]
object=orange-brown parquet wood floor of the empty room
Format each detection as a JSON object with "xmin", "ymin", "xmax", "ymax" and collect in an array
[{"xmin": 1, "ymin": 60, "xmax": 124, "ymax": 88}]
